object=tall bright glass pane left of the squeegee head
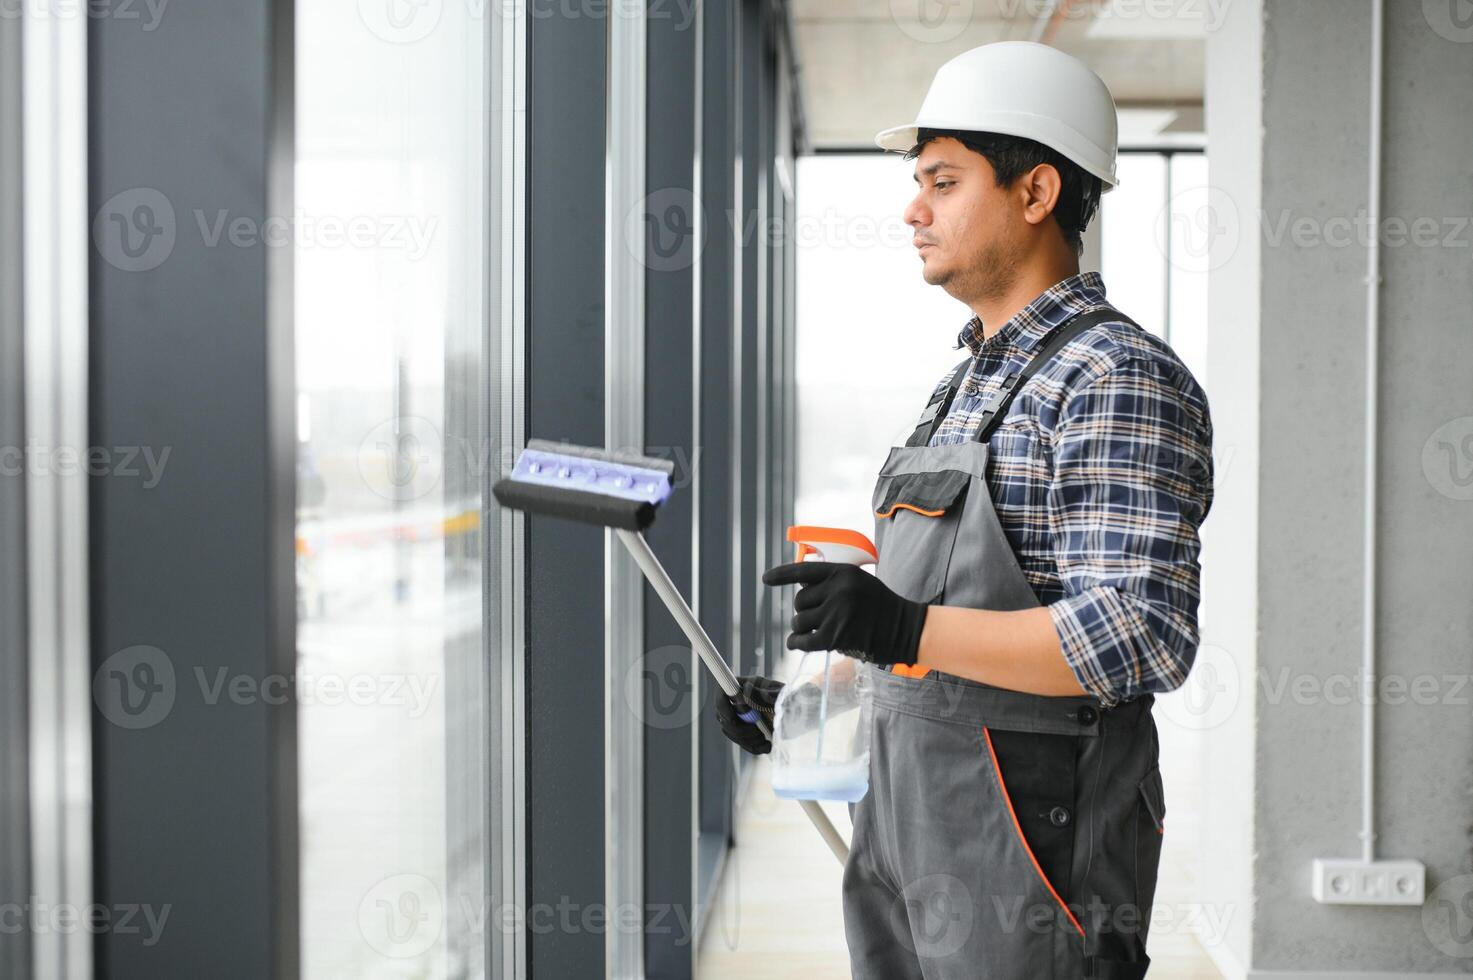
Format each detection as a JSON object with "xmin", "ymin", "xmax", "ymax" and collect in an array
[{"xmin": 293, "ymin": 0, "xmax": 488, "ymax": 977}]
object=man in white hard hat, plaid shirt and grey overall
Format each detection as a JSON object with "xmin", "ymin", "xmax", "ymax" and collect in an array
[{"xmin": 717, "ymin": 41, "xmax": 1212, "ymax": 980}]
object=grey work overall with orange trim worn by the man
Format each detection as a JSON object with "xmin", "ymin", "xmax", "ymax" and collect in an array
[{"xmin": 843, "ymin": 309, "xmax": 1165, "ymax": 980}]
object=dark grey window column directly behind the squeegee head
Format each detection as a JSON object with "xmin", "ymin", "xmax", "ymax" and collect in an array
[{"xmin": 526, "ymin": 6, "xmax": 608, "ymax": 980}]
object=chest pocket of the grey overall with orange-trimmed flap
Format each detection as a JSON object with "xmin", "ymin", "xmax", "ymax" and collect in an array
[{"xmin": 873, "ymin": 470, "xmax": 971, "ymax": 603}]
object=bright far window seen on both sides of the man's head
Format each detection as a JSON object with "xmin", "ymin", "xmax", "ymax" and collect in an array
[{"xmin": 795, "ymin": 150, "xmax": 1207, "ymax": 524}]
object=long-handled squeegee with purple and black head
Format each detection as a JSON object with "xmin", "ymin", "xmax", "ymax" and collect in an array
[{"xmin": 492, "ymin": 439, "xmax": 848, "ymax": 864}]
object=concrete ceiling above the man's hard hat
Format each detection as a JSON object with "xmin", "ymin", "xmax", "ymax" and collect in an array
[{"xmin": 791, "ymin": 0, "xmax": 1201, "ymax": 149}]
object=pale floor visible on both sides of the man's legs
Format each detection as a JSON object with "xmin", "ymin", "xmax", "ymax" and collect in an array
[{"xmin": 697, "ymin": 707, "xmax": 1221, "ymax": 980}]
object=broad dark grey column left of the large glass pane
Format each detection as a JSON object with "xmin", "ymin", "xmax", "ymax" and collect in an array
[{"xmin": 88, "ymin": 0, "xmax": 296, "ymax": 979}]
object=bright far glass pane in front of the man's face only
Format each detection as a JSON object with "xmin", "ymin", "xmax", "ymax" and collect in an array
[{"xmin": 794, "ymin": 153, "xmax": 972, "ymax": 535}]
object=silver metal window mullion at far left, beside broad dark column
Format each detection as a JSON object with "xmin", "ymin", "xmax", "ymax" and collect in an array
[{"xmin": 21, "ymin": 5, "xmax": 93, "ymax": 977}]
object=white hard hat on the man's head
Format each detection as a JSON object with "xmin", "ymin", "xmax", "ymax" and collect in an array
[{"xmin": 875, "ymin": 41, "xmax": 1118, "ymax": 190}]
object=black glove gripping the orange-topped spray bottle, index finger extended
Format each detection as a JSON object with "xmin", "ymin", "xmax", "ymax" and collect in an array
[{"xmin": 762, "ymin": 561, "xmax": 928, "ymax": 665}]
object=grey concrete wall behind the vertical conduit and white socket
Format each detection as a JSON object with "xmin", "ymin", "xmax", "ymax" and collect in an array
[{"xmin": 1203, "ymin": 0, "xmax": 1473, "ymax": 976}]
